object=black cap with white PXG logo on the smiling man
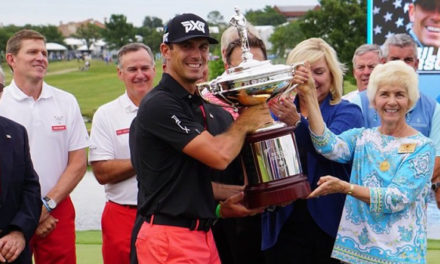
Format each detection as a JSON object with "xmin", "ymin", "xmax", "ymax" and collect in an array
[{"xmin": 163, "ymin": 13, "xmax": 218, "ymax": 44}]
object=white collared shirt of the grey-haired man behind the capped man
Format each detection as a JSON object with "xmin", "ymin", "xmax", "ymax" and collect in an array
[{"xmin": 89, "ymin": 92, "xmax": 138, "ymax": 205}]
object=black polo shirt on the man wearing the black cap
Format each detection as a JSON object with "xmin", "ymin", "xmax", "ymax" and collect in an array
[{"xmin": 130, "ymin": 73, "xmax": 233, "ymax": 219}]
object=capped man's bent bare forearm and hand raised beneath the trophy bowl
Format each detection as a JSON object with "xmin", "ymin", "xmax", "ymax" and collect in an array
[{"xmin": 183, "ymin": 104, "xmax": 273, "ymax": 170}]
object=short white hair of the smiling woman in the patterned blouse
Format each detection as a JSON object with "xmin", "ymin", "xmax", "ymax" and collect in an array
[{"xmin": 367, "ymin": 60, "xmax": 420, "ymax": 111}]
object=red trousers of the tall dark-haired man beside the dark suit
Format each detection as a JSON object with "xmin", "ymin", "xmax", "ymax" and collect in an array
[{"xmin": 30, "ymin": 196, "xmax": 76, "ymax": 264}]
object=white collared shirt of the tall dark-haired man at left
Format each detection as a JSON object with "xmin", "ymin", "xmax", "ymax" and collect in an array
[{"xmin": 0, "ymin": 81, "xmax": 89, "ymax": 196}]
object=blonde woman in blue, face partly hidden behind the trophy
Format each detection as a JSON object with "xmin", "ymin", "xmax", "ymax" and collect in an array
[{"xmin": 263, "ymin": 38, "xmax": 363, "ymax": 263}]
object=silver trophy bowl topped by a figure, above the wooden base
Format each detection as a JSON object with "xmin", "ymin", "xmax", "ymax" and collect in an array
[{"xmin": 197, "ymin": 7, "xmax": 303, "ymax": 108}]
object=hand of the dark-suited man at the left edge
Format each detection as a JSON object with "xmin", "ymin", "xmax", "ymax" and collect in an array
[{"xmin": 0, "ymin": 231, "xmax": 26, "ymax": 263}]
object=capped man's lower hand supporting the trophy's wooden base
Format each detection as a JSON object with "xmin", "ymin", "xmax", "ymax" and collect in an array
[{"xmin": 220, "ymin": 192, "xmax": 264, "ymax": 218}]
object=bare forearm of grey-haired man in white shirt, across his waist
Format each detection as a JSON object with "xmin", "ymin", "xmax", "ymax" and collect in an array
[{"xmin": 91, "ymin": 159, "xmax": 136, "ymax": 184}]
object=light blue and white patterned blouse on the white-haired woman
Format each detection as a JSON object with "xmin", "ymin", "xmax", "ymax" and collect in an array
[{"xmin": 311, "ymin": 128, "xmax": 435, "ymax": 264}]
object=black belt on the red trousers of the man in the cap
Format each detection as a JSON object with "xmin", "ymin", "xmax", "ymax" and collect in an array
[{"xmin": 145, "ymin": 215, "xmax": 214, "ymax": 232}]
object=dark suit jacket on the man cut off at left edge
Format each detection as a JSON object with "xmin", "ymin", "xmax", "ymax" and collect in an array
[{"xmin": 0, "ymin": 117, "xmax": 44, "ymax": 263}]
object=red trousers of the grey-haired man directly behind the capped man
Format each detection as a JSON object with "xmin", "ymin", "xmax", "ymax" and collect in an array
[{"xmin": 101, "ymin": 202, "xmax": 136, "ymax": 264}]
